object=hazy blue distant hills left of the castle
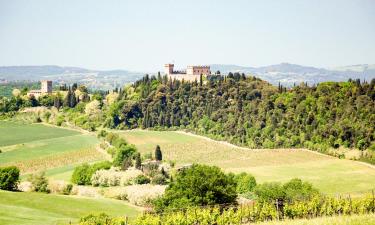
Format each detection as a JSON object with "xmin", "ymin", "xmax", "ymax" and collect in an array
[{"xmin": 0, "ymin": 65, "xmax": 144, "ymax": 90}]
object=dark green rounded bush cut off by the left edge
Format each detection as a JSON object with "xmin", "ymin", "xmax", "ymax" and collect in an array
[{"xmin": 0, "ymin": 166, "xmax": 20, "ymax": 191}]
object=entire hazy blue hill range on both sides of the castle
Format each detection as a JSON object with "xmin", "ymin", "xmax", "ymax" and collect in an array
[{"xmin": 0, "ymin": 63, "xmax": 375, "ymax": 90}]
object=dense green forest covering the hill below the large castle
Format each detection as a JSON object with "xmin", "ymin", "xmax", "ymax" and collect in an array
[{"xmin": 106, "ymin": 73, "xmax": 375, "ymax": 153}]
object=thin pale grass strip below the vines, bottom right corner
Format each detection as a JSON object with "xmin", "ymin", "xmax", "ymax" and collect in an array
[{"xmin": 258, "ymin": 214, "xmax": 375, "ymax": 225}]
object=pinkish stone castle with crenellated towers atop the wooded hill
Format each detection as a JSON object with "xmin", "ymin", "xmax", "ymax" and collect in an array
[{"xmin": 164, "ymin": 64, "xmax": 211, "ymax": 81}]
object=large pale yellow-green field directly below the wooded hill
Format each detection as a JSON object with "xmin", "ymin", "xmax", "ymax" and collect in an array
[{"xmin": 119, "ymin": 130, "xmax": 375, "ymax": 194}]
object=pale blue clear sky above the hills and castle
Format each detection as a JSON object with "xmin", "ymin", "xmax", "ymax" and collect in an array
[{"xmin": 0, "ymin": 0, "xmax": 375, "ymax": 71}]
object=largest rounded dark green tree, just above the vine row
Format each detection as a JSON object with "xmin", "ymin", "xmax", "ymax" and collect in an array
[{"xmin": 155, "ymin": 164, "xmax": 237, "ymax": 211}]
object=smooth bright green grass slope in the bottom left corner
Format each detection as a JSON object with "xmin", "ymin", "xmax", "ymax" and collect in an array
[{"xmin": 0, "ymin": 191, "xmax": 140, "ymax": 225}]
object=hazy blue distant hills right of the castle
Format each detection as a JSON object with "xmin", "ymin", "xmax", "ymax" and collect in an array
[{"xmin": 211, "ymin": 63, "xmax": 375, "ymax": 86}]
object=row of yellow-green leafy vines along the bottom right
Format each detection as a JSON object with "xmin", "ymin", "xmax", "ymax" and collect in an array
[{"xmin": 133, "ymin": 194, "xmax": 375, "ymax": 225}]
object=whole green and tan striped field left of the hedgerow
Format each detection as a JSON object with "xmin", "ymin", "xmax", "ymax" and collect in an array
[{"xmin": 0, "ymin": 121, "xmax": 104, "ymax": 178}]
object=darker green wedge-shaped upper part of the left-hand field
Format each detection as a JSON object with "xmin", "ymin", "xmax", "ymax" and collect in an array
[{"xmin": 0, "ymin": 121, "xmax": 80, "ymax": 147}]
